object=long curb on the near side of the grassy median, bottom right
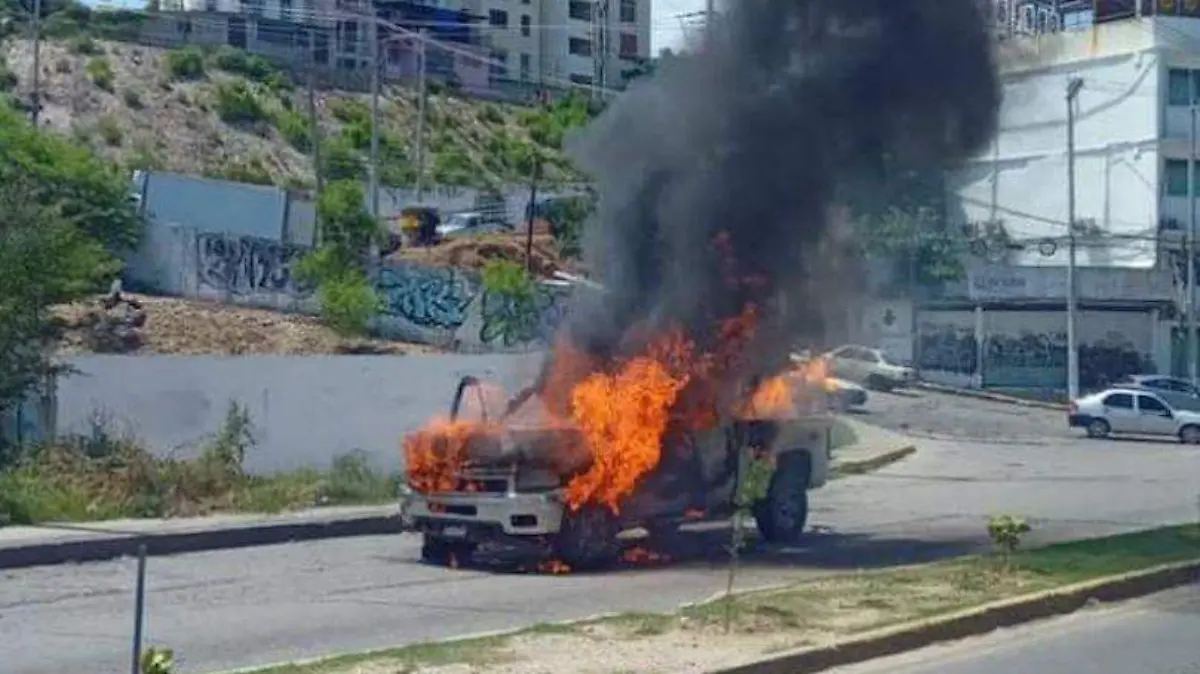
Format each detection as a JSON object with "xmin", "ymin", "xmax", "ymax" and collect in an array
[{"xmin": 708, "ymin": 560, "xmax": 1200, "ymax": 674}]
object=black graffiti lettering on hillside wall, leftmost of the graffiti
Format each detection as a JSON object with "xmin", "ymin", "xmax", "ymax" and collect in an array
[{"xmin": 196, "ymin": 233, "xmax": 312, "ymax": 297}]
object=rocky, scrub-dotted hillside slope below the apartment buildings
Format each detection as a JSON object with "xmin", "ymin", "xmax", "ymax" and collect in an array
[{"xmin": 0, "ymin": 37, "xmax": 574, "ymax": 187}]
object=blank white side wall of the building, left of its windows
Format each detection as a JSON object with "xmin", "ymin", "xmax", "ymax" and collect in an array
[{"xmin": 950, "ymin": 19, "xmax": 1163, "ymax": 267}]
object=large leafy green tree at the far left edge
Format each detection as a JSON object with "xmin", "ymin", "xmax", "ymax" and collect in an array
[{"xmin": 0, "ymin": 98, "xmax": 140, "ymax": 419}]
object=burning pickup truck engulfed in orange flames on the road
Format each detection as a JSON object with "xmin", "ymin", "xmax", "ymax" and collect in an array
[{"xmin": 401, "ymin": 357, "xmax": 833, "ymax": 570}]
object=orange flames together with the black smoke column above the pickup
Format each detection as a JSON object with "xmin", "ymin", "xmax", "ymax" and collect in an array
[{"xmin": 404, "ymin": 0, "xmax": 1000, "ymax": 512}]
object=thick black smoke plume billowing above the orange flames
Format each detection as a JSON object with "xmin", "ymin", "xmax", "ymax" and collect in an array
[{"xmin": 532, "ymin": 0, "xmax": 1000, "ymax": 407}]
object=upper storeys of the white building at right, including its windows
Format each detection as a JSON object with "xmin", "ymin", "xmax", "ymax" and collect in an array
[{"xmin": 950, "ymin": 2, "xmax": 1200, "ymax": 269}]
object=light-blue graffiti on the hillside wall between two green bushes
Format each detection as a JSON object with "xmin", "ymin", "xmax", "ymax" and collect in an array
[{"xmin": 376, "ymin": 265, "xmax": 475, "ymax": 330}]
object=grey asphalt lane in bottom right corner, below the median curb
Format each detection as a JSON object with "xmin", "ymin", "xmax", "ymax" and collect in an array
[{"xmin": 830, "ymin": 585, "xmax": 1200, "ymax": 674}]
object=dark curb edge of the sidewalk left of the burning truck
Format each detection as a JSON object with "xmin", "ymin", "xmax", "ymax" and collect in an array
[{"xmin": 0, "ymin": 514, "xmax": 403, "ymax": 568}]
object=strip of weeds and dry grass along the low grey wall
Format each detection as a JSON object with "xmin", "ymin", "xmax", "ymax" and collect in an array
[{"xmin": 0, "ymin": 402, "xmax": 396, "ymax": 524}]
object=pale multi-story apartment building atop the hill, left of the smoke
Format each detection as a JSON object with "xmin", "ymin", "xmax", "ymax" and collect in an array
[{"xmin": 416, "ymin": 0, "xmax": 652, "ymax": 88}]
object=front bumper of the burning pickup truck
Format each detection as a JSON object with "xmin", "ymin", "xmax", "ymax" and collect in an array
[{"xmin": 400, "ymin": 484, "xmax": 563, "ymax": 540}]
